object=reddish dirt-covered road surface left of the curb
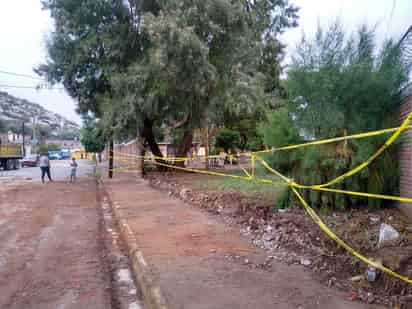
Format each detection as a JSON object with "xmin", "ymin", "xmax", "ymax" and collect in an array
[{"xmin": 0, "ymin": 179, "xmax": 111, "ymax": 309}]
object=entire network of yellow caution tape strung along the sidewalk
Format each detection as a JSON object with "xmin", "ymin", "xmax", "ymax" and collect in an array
[{"xmin": 107, "ymin": 113, "xmax": 412, "ymax": 284}]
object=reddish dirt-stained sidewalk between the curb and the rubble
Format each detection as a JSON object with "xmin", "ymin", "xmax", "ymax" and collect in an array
[{"xmin": 105, "ymin": 174, "xmax": 381, "ymax": 309}]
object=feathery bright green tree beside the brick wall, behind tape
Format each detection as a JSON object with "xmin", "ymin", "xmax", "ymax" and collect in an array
[{"xmin": 261, "ymin": 22, "xmax": 410, "ymax": 208}]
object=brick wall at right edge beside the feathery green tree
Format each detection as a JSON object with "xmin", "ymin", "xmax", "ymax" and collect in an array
[{"xmin": 399, "ymin": 84, "xmax": 412, "ymax": 218}]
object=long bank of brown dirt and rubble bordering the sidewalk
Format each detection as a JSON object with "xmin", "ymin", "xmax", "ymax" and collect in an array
[{"xmin": 148, "ymin": 173, "xmax": 412, "ymax": 308}]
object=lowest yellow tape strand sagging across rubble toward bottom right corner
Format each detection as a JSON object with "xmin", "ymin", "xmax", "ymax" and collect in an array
[{"xmin": 292, "ymin": 187, "xmax": 412, "ymax": 284}]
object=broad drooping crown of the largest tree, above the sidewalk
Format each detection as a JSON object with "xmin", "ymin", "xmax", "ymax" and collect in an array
[{"xmin": 36, "ymin": 0, "xmax": 297, "ymax": 156}]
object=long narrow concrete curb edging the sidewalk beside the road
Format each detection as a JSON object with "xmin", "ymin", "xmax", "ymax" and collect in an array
[{"xmin": 99, "ymin": 181, "xmax": 169, "ymax": 309}]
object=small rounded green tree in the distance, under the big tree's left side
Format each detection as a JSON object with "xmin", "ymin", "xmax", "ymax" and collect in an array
[{"xmin": 80, "ymin": 120, "xmax": 107, "ymax": 153}]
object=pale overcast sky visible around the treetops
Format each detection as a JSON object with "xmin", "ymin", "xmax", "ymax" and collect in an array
[{"xmin": 0, "ymin": 0, "xmax": 412, "ymax": 122}]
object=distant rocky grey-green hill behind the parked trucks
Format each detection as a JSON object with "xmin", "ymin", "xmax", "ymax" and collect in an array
[{"xmin": 0, "ymin": 91, "xmax": 80, "ymax": 137}]
